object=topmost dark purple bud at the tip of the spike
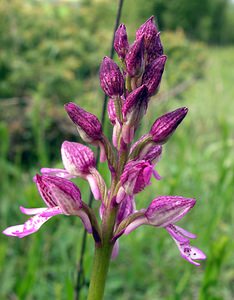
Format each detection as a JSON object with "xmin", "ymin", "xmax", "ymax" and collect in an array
[{"xmin": 136, "ymin": 16, "xmax": 163, "ymax": 64}]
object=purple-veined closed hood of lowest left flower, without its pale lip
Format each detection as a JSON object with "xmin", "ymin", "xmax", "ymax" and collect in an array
[{"xmin": 35, "ymin": 175, "xmax": 82, "ymax": 215}]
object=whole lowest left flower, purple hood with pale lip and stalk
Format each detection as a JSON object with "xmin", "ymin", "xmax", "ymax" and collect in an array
[{"xmin": 3, "ymin": 175, "xmax": 92, "ymax": 238}]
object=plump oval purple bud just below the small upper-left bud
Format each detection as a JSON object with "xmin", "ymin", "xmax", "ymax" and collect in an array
[{"xmin": 99, "ymin": 56, "xmax": 124, "ymax": 97}]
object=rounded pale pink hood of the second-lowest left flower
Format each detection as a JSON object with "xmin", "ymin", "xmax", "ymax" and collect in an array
[{"xmin": 61, "ymin": 141, "xmax": 96, "ymax": 177}]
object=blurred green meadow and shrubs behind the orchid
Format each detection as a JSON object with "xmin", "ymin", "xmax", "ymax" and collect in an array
[{"xmin": 0, "ymin": 0, "xmax": 234, "ymax": 300}]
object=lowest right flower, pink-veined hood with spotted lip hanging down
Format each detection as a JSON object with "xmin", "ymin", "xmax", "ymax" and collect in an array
[{"xmin": 121, "ymin": 196, "xmax": 206, "ymax": 266}]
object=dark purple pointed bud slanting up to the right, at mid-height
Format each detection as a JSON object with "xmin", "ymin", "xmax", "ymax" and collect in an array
[{"xmin": 150, "ymin": 107, "xmax": 188, "ymax": 144}]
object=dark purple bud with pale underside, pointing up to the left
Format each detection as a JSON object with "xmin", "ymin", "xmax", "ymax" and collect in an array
[{"xmin": 65, "ymin": 102, "xmax": 102, "ymax": 143}]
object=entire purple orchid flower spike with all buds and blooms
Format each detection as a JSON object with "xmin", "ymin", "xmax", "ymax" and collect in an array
[{"xmin": 3, "ymin": 17, "xmax": 206, "ymax": 265}]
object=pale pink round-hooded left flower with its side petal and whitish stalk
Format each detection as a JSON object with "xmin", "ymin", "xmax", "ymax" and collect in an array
[{"xmin": 41, "ymin": 141, "xmax": 106, "ymax": 200}]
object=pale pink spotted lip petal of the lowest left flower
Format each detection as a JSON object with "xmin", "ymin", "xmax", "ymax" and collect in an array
[{"xmin": 3, "ymin": 207, "xmax": 61, "ymax": 238}]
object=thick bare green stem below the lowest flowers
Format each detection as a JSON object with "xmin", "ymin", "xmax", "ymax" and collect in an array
[{"xmin": 88, "ymin": 242, "xmax": 113, "ymax": 300}]
